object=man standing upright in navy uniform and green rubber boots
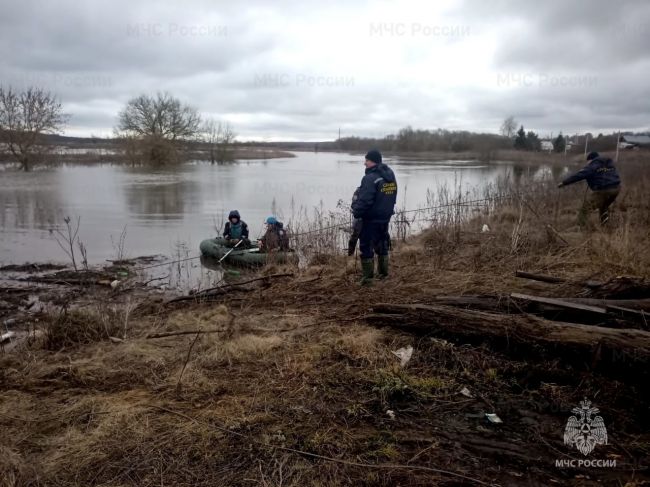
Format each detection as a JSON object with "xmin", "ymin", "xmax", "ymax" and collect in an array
[{"xmin": 352, "ymin": 150, "xmax": 397, "ymax": 285}]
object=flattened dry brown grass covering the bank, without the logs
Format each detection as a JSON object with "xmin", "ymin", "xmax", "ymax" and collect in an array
[{"xmin": 0, "ymin": 151, "xmax": 650, "ymax": 487}]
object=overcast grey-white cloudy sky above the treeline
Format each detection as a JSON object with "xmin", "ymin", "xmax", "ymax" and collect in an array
[{"xmin": 0, "ymin": 0, "xmax": 650, "ymax": 140}]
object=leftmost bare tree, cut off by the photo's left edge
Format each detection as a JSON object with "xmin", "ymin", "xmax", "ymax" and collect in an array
[{"xmin": 0, "ymin": 87, "xmax": 69, "ymax": 171}]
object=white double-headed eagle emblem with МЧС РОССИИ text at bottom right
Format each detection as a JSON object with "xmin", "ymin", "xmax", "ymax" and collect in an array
[{"xmin": 555, "ymin": 399, "xmax": 616, "ymax": 468}]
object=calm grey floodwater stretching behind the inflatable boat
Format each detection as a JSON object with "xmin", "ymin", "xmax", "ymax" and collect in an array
[{"xmin": 0, "ymin": 152, "xmax": 556, "ymax": 288}]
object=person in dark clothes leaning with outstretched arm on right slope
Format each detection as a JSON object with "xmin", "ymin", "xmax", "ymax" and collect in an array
[{"xmin": 558, "ymin": 152, "xmax": 621, "ymax": 227}]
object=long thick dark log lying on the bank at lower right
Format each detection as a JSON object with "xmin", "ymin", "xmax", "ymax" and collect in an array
[{"xmin": 366, "ymin": 304, "xmax": 650, "ymax": 382}]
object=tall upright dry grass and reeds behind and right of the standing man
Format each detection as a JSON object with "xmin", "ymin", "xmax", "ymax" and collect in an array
[{"xmin": 288, "ymin": 152, "xmax": 650, "ymax": 275}]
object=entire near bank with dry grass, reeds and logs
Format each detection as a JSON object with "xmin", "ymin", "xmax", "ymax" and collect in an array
[{"xmin": 0, "ymin": 152, "xmax": 650, "ymax": 487}]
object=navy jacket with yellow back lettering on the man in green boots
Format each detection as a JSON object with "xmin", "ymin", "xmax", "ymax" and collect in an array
[{"xmin": 352, "ymin": 164, "xmax": 397, "ymax": 223}]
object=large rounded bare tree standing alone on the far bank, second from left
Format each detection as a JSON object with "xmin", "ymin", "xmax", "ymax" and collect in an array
[{"xmin": 116, "ymin": 93, "xmax": 201, "ymax": 164}]
